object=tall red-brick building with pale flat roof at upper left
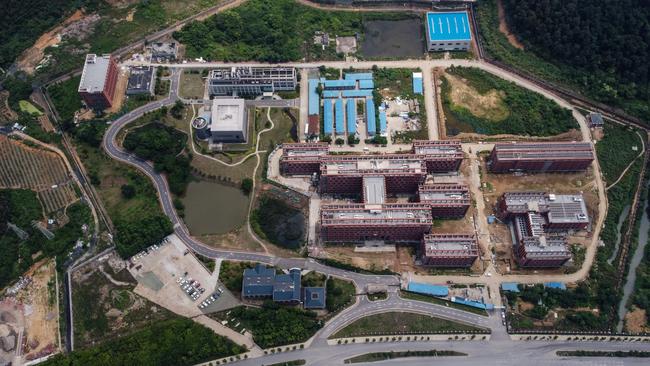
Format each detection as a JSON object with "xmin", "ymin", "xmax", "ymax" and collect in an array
[{"xmin": 78, "ymin": 54, "xmax": 118, "ymax": 110}]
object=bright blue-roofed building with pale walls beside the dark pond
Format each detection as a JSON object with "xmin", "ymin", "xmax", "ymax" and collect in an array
[{"xmin": 425, "ymin": 11, "xmax": 472, "ymax": 51}]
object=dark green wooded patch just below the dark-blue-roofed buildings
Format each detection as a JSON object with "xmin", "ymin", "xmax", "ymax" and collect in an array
[{"xmin": 210, "ymin": 300, "xmax": 323, "ymax": 348}]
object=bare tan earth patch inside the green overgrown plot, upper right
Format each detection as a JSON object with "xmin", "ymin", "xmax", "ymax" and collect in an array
[{"xmin": 445, "ymin": 74, "xmax": 510, "ymax": 122}]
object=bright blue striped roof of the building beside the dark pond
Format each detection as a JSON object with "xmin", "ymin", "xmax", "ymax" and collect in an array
[{"xmin": 427, "ymin": 11, "xmax": 471, "ymax": 41}]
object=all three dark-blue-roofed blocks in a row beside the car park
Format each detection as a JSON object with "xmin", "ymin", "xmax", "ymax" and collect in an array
[{"xmin": 242, "ymin": 263, "xmax": 326, "ymax": 309}]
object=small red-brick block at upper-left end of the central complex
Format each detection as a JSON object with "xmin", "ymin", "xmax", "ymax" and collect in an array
[{"xmin": 280, "ymin": 142, "xmax": 329, "ymax": 175}]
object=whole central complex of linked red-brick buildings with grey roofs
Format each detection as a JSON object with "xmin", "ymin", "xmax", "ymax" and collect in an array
[{"xmin": 280, "ymin": 140, "xmax": 478, "ymax": 266}]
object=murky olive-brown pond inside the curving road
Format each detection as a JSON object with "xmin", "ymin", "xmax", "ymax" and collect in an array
[{"xmin": 182, "ymin": 180, "xmax": 248, "ymax": 235}]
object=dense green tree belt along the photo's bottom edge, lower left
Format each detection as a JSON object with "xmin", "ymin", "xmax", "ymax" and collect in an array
[{"xmin": 42, "ymin": 319, "xmax": 245, "ymax": 366}]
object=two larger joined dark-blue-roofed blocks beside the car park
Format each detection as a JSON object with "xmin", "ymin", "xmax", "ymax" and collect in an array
[{"xmin": 242, "ymin": 263, "xmax": 301, "ymax": 302}]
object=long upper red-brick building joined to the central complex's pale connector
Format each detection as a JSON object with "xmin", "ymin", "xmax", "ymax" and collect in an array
[{"xmin": 320, "ymin": 154, "xmax": 427, "ymax": 194}]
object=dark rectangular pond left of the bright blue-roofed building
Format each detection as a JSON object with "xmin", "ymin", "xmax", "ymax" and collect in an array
[{"xmin": 361, "ymin": 18, "xmax": 425, "ymax": 58}]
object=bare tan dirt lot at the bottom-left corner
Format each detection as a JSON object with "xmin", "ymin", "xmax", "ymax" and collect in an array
[{"xmin": 0, "ymin": 260, "xmax": 61, "ymax": 362}]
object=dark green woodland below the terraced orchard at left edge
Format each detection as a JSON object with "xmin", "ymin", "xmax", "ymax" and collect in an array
[{"xmin": 0, "ymin": 189, "xmax": 92, "ymax": 288}]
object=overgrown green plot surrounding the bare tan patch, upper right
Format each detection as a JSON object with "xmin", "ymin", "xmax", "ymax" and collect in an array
[{"xmin": 441, "ymin": 66, "xmax": 578, "ymax": 136}]
